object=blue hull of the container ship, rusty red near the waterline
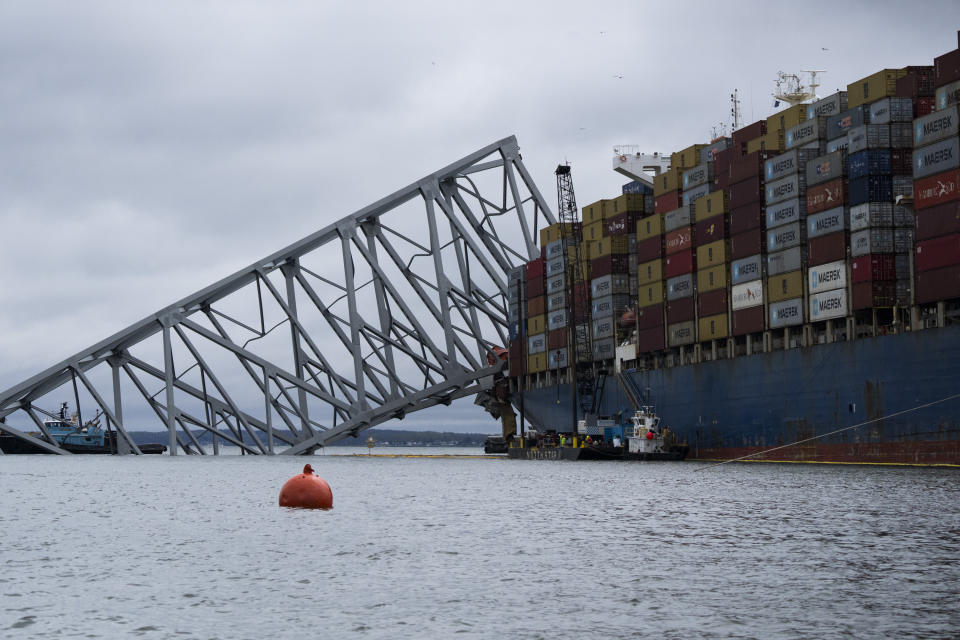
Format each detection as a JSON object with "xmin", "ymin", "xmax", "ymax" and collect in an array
[{"xmin": 514, "ymin": 327, "xmax": 960, "ymax": 464}]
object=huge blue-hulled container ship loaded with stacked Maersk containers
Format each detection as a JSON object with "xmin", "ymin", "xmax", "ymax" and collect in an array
[{"xmin": 505, "ymin": 34, "xmax": 960, "ymax": 465}]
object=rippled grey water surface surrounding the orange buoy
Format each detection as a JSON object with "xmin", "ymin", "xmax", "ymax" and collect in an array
[{"xmin": 0, "ymin": 449, "xmax": 960, "ymax": 639}]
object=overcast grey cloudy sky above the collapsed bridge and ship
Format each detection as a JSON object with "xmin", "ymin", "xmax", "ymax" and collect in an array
[{"xmin": 0, "ymin": 0, "xmax": 960, "ymax": 430}]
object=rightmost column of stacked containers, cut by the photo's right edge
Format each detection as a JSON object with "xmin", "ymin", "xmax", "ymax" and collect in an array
[{"xmin": 913, "ymin": 41, "xmax": 960, "ymax": 304}]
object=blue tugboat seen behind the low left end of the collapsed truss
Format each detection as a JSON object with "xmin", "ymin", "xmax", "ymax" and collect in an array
[{"xmin": 0, "ymin": 402, "xmax": 167, "ymax": 454}]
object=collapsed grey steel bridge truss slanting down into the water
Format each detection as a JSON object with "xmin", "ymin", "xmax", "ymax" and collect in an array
[{"xmin": 0, "ymin": 136, "xmax": 556, "ymax": 454}]
